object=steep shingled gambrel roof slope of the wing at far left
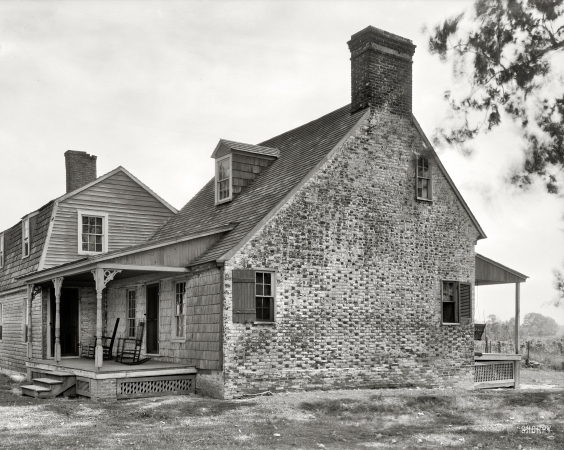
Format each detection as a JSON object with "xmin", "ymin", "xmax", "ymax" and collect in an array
[{"xmin": 0, "ymin": 201, "xmax": 54, "ymax": 292}]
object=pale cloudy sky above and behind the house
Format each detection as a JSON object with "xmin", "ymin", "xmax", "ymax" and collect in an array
[{"xmin": 0, "ymin": 0, "xmax": 564, "ymax": 325}]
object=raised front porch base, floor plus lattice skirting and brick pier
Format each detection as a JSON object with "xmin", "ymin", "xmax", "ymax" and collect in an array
[{"xmin": 26, "ymin": 358, "xmax": 197, "ymax": 399}]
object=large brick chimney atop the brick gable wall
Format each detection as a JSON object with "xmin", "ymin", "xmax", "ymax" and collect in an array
[{"xmin": 348, "ymin": 27, "xmax": 415, "ymax": 116}]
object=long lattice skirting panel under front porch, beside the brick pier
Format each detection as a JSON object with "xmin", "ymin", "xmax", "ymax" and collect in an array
[{"xmin": 117, "ymin": 375, "xmax": 196, "ymax": 398}]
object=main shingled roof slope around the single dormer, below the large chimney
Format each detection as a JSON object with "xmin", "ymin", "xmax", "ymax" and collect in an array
[{"xmin": 149, "ymin": 105, "xmax": 366, "ymax": 264}]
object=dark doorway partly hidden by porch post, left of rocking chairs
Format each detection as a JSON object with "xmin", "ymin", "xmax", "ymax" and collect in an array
[{"xmin": 49, "ymin": 288, "xmax": 79, "ymax": 356}]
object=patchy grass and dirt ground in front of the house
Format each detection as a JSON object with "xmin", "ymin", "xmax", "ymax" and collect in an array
[{"xmin": 0, "ymin": 369, "xmax": 564, "ymax": 450}]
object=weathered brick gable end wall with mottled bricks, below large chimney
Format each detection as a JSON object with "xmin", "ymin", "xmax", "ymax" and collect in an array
[{"xmin": 223, "ymin": 111, "xmax": 478, "ymax": 397}]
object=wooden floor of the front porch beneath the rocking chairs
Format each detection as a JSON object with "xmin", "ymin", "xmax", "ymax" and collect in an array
[{"xmin": 26, "ymin": 358, "xmax": 197, "ymax": 379}]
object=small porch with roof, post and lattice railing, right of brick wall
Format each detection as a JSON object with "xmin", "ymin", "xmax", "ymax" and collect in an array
[{"xmin": 474, "ymin": 254, "xmax": 528, "ymax": 389}]
